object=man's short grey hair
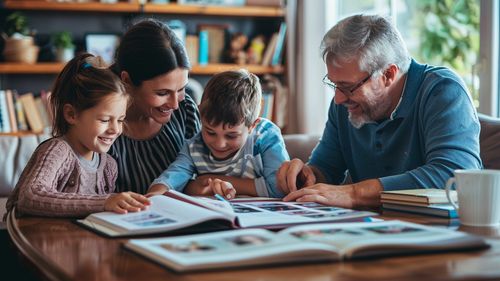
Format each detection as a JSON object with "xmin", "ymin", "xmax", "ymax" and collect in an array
[{"xmin": 321, "ymin": 15, "xmax": 411, "ymax": 73}]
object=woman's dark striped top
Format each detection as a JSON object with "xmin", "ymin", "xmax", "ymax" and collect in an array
[{"xmin": 108, "ymin": 95, "xmax": 200, "ymax": 194}]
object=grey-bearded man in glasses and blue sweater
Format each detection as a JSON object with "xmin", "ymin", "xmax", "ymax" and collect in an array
[{"xmin": 277, "ymin": 15, "xmax": 482, "ymax": 208}]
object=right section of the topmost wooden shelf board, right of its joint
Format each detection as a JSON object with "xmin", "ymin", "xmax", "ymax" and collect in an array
[{"xmin": 144, "ymin": 4, "xmax": 285, "ymax": 17}]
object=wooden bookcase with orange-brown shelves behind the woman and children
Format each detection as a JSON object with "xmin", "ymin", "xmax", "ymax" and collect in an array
[{"xmin": 0, "ymin": 0, "xmax": 286, "ymax": 135}]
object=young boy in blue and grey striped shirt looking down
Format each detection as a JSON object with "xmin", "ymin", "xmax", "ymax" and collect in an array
[{"xmin": 148, "ymin": 70, "xmax": 289, "ymax": 199}]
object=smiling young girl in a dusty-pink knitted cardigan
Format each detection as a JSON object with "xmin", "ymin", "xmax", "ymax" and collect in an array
[{"xmin": 7, "ymin": 54, "xmax": 149, "ymax": 217}]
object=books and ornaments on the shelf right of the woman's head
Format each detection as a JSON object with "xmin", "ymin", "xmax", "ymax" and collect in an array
[{"xmin": 182, "ymin": 21, "xmax": 286, "ymax": 66}]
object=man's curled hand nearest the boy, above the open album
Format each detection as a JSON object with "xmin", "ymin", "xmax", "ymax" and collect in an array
[{"xmin": 276, "ymin": 158, "xmax": 316, "ymax": 194}]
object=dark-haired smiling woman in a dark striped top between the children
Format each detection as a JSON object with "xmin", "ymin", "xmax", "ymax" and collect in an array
[{"xmin": 109, "ymin": 19, "xmax": 200, "ymax": 194}]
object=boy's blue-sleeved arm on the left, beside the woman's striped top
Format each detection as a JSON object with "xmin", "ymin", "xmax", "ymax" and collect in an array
[{"xmin": 148, "ymin": 142, "xmax": 196, "ymax": 193}]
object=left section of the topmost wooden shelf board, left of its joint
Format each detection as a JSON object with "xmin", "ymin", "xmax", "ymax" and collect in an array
[{"xmin": 4, "ymin": 0, "xmax": 141, "ymax": 13}]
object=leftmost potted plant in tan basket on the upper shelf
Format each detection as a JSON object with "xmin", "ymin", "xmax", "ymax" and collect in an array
[{"xmin": 2, "ymin": 12, "xmax": 39, "ymax": 63}]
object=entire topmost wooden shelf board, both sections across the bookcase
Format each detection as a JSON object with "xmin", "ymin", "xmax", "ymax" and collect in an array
[{"xmin": 4, "ymin": 0, "xmax": 285, "ymax": 17}]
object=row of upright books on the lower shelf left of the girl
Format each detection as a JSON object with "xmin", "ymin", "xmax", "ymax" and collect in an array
[{"xmin": 0, "ymin": 90, "xmax": 52, "ymax": 133}]
